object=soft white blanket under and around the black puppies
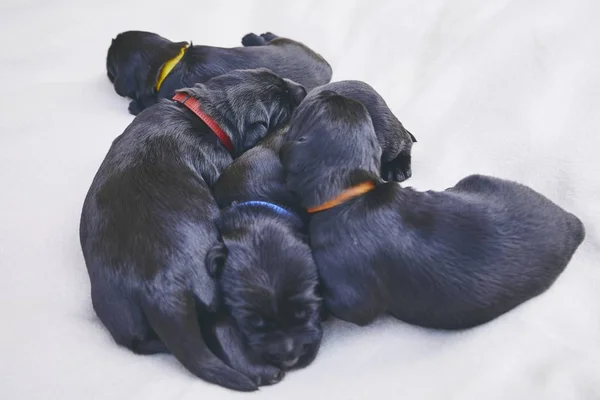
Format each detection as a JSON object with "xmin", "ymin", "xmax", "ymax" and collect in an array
[{"xmin": 0, "ymin": 0, "xmax": 600, "ymax": 400}]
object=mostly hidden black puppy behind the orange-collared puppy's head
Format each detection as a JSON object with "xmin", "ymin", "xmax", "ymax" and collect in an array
[{"xmin": 309, "ymin": 81, "xmax": 417, "ymax": 182}]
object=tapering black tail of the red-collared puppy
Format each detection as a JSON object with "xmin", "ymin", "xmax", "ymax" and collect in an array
[{"xmin": 143, "ymin": 294, "xmax": 258, "ymax": 392}]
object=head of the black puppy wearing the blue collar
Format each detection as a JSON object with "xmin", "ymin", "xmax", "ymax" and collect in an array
[{"xmin": 207, "ymin": 216, "xmax": 322, "ymax": 369}]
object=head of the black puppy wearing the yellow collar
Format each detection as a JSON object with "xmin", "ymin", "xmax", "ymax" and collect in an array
[{"xmin": 106, "ymin": 31, "xmax": 187, "ymax": 99}]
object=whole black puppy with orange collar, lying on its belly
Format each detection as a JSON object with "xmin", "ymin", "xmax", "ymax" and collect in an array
[{"xmin": 281, "ymin": 92, "xmax": 585, "ymax": 329}]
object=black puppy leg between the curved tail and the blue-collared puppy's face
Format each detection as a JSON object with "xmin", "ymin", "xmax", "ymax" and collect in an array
[{"xmin": 205, "ymin": 316, "xmax": 285, "ymax": 386}]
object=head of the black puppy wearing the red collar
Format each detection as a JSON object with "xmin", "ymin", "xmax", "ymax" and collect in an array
[{"xmin": 178, "ymin": 68, "xmax": 306, "ymax": 155}]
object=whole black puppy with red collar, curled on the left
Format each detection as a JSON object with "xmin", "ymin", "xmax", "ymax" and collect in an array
[{"xmin": 80, "ymin": 69, "xmax": 306, "ymax": 391}]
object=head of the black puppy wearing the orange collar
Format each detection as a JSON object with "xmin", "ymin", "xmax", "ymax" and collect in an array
[{"xmin": 280, "ymin": 91, "xmax": 381, "ymax": 207}]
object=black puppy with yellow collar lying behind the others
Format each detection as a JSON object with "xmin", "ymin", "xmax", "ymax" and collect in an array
[{"xmin": 106, "ymin": 31, "xmax": 331, "ymax": 115}]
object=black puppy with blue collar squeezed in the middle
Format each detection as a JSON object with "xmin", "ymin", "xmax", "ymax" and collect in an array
[{"xmin": 206, "ymin": 129, "xmax": 322, "ymax": 380}]
